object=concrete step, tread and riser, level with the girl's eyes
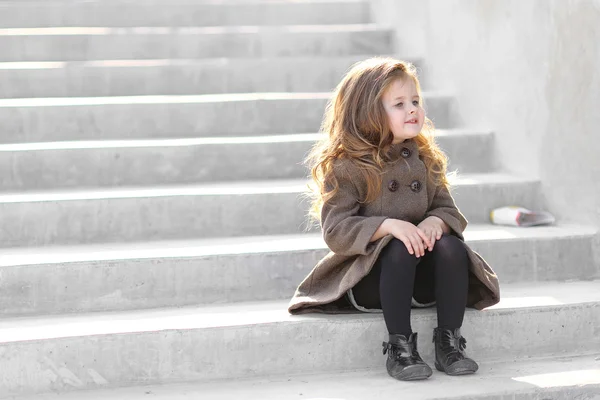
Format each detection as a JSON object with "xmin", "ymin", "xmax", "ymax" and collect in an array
[{"xmin": 0, "ymin": 92, "xmax": 454, "ymax": 143}]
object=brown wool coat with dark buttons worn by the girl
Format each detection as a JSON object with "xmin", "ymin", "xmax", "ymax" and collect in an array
[{"xmin": 288, "ymin": 140, "xmax": 500, "ymax": 314}]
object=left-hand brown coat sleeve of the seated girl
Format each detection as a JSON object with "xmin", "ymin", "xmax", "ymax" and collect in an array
[{"xmin": 321, "ymin": 164, "xmax": 387, "ymax": 256}]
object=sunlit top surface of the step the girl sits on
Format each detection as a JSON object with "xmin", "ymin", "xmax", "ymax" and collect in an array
[{"xmin": 0, "ymin": 280, "xmax": 600, "ymax": 345}]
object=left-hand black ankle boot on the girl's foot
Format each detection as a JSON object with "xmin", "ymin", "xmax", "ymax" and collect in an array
[{"xmin": 383, "ymin": 333, "xmax": 433, "ymax": 381}]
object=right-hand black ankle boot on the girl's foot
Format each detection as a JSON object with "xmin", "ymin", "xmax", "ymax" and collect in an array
[{"xmin": 433, "ymin": 328, "xmax": 479, "ymax": 375}]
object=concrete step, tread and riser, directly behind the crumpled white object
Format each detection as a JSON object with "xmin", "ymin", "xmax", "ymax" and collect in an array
[{"xmin": 0, "ymin": 174, "xmax": 540, "ymax": 247}]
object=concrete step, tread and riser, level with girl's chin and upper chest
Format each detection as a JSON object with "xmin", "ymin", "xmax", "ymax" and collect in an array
[{"xmin": 0, "ymin": 130, "xmax": 493, "ymax": 191}]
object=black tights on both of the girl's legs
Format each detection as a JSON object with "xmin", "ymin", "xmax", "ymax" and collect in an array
[{"xmin": 352, "ymin": 235, "xmax": 469, "ymax": 337}]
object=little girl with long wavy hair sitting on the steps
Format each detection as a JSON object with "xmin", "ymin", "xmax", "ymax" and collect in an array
[{"xmin": 289, "ymin": 58, "xmax": 500, "ymax": 380}]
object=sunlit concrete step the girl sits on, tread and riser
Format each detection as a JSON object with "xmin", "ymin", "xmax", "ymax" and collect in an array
[{"xmin": 0, "ymin": 281, "xmax": 600, "ymax": 396}]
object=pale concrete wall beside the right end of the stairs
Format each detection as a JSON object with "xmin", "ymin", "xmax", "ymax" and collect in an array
[{"xmin": 372, "ymin": 0, "xmax": 600, "ymax": 226}]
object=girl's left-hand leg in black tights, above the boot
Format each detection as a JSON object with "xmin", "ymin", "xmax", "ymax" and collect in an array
[{"xmin": 352, "ymin": 239, "xmax": 419, "ymax": 338}]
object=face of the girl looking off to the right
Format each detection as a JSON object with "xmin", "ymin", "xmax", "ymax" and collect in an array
[{"xmin": 382, "ymin": 78, "xmax": 425, "ymax": 144}]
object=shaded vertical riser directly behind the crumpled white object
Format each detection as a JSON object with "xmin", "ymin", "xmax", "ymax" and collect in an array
[{"xmin": 0, "ymin": 183, "xmax": 539, "ymax": 247}]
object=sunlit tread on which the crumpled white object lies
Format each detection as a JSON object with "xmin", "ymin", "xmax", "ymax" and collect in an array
[{"xmin": 0, "ymin": 224, "xmax": 597, "ymax": 267}]
